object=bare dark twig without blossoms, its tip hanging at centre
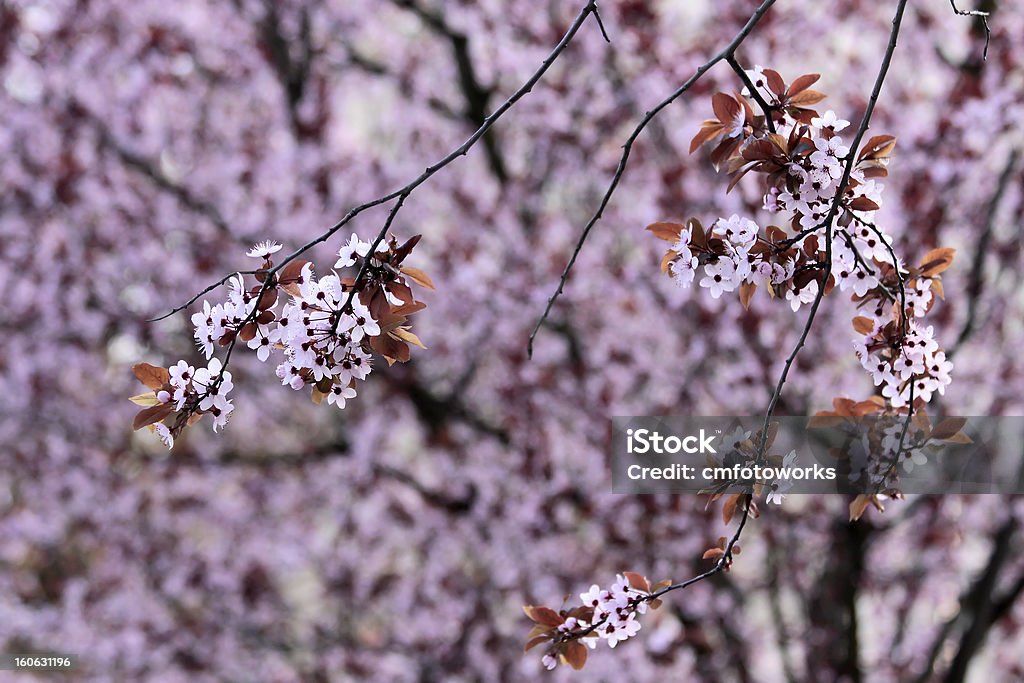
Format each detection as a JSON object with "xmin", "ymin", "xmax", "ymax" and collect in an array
[{"xmin": 526, "ymin": 0, "xmax": 775, "ymax": 357}]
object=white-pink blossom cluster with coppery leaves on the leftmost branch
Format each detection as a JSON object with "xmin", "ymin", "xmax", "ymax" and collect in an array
[{"xmin": 132, "ymin": 234, "xmax": 433, "ymax": 447}]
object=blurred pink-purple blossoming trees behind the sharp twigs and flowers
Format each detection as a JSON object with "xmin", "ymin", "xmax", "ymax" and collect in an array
[{"xmin": 0, "ymin": 0, "xmax": 1024, "ymax": 683}]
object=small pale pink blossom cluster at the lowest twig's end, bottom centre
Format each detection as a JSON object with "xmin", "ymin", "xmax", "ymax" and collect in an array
[{"xmin": 524, "ymin": 571, "xmax": 671, "ymax": 670}]
